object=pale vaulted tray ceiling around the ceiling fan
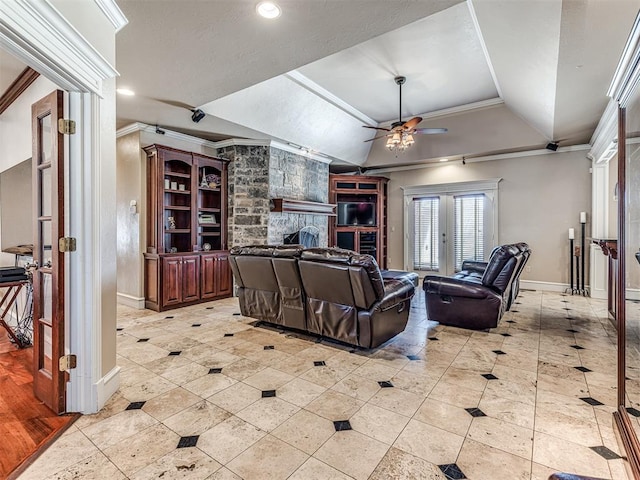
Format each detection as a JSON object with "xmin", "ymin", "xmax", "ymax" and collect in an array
[{"xmin": 8, "ymin": 0, "xmax": 640, "ymax": 167}]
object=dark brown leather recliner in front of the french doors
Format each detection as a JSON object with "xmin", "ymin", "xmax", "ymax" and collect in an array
[{"xmin": 422, "ymin": 245, "xmax": 523, "ymax": 330}]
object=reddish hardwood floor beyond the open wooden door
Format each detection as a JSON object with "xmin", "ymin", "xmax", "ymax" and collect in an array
[{"xmin": 0, "ymin": 331, "xmax": 77, "ymax": 478}]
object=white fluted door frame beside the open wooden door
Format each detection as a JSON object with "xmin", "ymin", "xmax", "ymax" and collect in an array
[{"xmin": 0, "ymin": 0, "xmax": 126, "ymax": 413}]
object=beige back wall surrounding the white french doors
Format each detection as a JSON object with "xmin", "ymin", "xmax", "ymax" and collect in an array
[{"xmin": 388, "ymin": 151, "xmax": 591, "ymax": 284}]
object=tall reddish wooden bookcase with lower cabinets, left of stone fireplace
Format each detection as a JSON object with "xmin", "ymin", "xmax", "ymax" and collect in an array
[{"xmin": 144, "ymin": 145, "xmax": 232, "ymax": 311}]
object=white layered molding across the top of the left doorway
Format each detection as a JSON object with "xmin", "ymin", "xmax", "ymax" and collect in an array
[{"xmin": 0, "ymin": 1, "xmax": 118, "ymax": 96}]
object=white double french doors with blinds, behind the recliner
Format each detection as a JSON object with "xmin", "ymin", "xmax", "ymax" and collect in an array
[{"xmin": 405, "ymin": 192, "xmax": 495, "ymax": 275}]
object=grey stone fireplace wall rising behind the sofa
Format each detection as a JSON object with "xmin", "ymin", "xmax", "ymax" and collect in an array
[{"xmin": 218, "ymin": 144, "xmax": 329, "ymax": 247}]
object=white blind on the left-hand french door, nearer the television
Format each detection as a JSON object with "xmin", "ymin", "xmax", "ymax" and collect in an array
[{"xmin": 413, "ymin": 197, "xmax": 440, "ymax": 271}]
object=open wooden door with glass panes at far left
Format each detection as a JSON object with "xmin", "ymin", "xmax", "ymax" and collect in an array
[{"xmin": 31, "ymin": 90, "xmax": 67, "ymax": 413}]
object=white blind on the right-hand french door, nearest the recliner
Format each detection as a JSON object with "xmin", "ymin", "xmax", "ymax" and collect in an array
[{"xmin": 453, "ymin": 194, "xmax": 485, "ymax": 271}]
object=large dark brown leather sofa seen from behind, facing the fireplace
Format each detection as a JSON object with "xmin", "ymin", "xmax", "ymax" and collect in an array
[{"xmin": 230, "ymin": 245, "xmax": 418, "ymax": 348}]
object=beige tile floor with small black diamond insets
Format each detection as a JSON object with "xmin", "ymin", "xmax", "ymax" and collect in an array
[{"xmin": 20, "ymin": 291, "xmax": 627, "ymax": 480}]
